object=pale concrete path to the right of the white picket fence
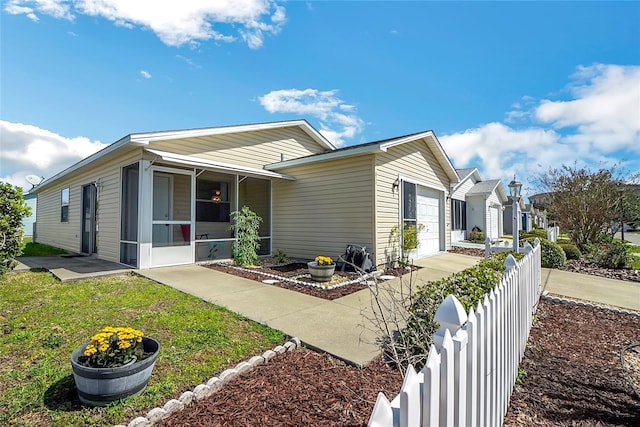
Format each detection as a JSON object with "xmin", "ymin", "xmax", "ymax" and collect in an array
[{"xmin": 542, "ymin": 268, "xmax": 640, "ymax": 311}]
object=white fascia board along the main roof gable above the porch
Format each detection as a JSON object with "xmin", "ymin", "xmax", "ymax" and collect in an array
[{"xmin": 131, "ymin": 120, "xmax": 336, "ymax": 150}]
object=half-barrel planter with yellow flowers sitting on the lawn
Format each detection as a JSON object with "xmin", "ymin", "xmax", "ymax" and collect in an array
[{"xmin": 71, "ymin": 326, "xmax": 160, "ymax": 406}]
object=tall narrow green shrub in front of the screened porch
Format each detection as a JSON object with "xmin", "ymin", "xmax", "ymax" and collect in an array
[{"xmin": 229, "ymin": 206, "xmax": 262, "ymax": 266}]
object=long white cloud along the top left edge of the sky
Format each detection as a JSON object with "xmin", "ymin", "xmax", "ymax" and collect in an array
[{"xmin": 4, "ymin": 0, "xmax": 286, "ymax": 49}]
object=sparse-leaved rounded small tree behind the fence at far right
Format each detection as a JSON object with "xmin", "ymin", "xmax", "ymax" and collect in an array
[{"xmin": 534, "ymin": 165, "xmax": 635, "ymax": 251}]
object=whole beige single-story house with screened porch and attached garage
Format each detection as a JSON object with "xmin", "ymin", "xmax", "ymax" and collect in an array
[{"xmin": 34, "ymin": 120, "xmax": 458, "ymax": 268}]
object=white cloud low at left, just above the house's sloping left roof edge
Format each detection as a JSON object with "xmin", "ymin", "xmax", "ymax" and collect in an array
[{"xmin": 0, "ymin": 120, "xmax": 107, "ymax": 189}]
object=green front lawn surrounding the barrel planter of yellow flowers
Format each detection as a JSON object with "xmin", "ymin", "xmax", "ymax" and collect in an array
[{"xmin": 0, "ymin": 271, "xmax": 285, "ymax": 426}]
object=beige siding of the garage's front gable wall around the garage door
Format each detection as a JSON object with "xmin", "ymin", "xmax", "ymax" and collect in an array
[{"xmin": 375, "ymin": 140, "xmax": 451, "ymax": 265}]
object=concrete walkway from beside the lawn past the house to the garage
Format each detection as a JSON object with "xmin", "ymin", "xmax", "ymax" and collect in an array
[{"xmin": 136, "ymin": 253, "xmax": 479, "ymax": 366}]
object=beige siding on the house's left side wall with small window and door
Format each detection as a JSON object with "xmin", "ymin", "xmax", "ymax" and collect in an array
[{"xmin": 36, "ymin": 149, "xmax": 142, "ymax": 262}]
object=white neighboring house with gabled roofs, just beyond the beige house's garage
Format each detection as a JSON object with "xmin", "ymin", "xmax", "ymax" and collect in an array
[{"xmin": 451, "ymin": 168, "xmax": 507, "ymax": 242}]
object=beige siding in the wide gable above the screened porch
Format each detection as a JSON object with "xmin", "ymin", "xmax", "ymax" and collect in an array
[{"xmin": 149, "ymin": 127, "xmax": 326, "ymax": 169}]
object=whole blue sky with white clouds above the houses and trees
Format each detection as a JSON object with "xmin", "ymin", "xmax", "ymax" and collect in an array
[{"xmin": 0, "ymin": 0, "xmax": 640, "ymax": 195}]
